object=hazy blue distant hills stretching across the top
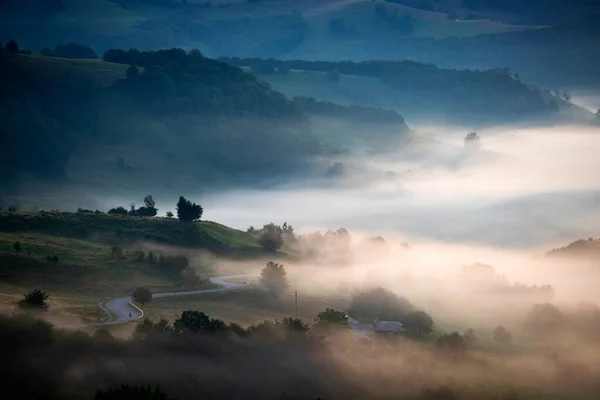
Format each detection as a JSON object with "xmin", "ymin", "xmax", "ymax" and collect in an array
[{"xmin": 0, "ymin": 0, "xmax": 600, "ymax": 90}]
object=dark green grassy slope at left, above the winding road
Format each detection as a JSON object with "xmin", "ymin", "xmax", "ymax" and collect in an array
[{"xmin": 0, "ymin": 213, "xmax": 260, "ymax": 320}]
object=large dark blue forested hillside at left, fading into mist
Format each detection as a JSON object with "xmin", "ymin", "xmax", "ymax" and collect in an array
[{"xmin": 0, "ymin": 45, "xmax": 407, "ymax": 188}]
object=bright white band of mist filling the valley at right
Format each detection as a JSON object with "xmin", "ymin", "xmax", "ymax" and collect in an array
[{"xmin": 205, "ymin": 126, "xmax": 600, "ymax": 248}]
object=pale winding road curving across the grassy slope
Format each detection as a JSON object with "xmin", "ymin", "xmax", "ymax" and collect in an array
[{"xmin": 93, "ymin": 275, "xmax": 248, "ymax": 325}]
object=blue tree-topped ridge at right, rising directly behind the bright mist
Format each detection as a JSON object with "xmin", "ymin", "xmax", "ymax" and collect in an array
[{"xmin": 221, "ymin": 57, "xmax": 560, "ymax": 123}]
